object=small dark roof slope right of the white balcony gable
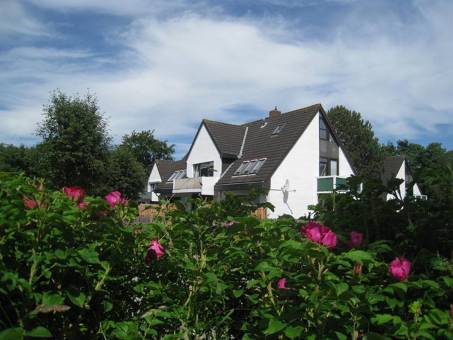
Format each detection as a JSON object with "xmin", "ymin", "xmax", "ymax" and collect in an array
[{"xmin": 202, "ymin": 119, "xmax": 246, "ymax": 158}]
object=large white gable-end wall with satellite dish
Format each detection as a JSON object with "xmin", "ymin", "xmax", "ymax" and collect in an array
[{"xmin": 267, "ymin": 113, "xmax": 320, "ymax": 218}]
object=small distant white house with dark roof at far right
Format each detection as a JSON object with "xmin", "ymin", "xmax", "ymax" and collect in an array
[{"xmin": 382, "ymin": 156, "xmax": 426, "ymax": 200}]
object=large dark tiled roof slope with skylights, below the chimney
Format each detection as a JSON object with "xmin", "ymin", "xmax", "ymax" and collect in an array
[{"xmin": 216, "ymin": 104, "xmax": 325, "ymax": 189}]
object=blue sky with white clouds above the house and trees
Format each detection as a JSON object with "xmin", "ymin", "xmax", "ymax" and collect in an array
[{"xmin": 0, "ymin": 0, "xmax": 453, "ymax": 157}]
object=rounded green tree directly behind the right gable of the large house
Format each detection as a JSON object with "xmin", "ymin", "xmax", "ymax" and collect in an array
[{"xmin": 327, "ymin": 106, "xmax": 382, "ymax": 178}]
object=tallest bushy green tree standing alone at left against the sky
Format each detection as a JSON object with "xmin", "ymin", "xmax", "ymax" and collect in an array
[{"xmin": 37, "ymin": 91, "xmax": 110, "ymax": 193}]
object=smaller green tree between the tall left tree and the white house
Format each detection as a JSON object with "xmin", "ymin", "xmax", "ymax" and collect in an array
[{"xmin": 121, "ymin": 130, "xmax": 175, "ymax": 172}]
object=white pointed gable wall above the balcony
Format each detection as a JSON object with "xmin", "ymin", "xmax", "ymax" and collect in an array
[{"xmin": 186, "ymin": 124, "xmax": 222, "ymax": 177}]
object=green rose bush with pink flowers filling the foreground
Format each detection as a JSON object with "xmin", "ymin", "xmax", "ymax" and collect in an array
[{"xmin": 0, "ymin": 175, "xmax": 453, "ymax": 339}]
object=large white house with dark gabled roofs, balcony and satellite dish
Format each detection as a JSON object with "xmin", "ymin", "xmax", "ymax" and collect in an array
[{"xmin": 148, "ymin": 104, "xmax": 354, "ymax": 218}]
